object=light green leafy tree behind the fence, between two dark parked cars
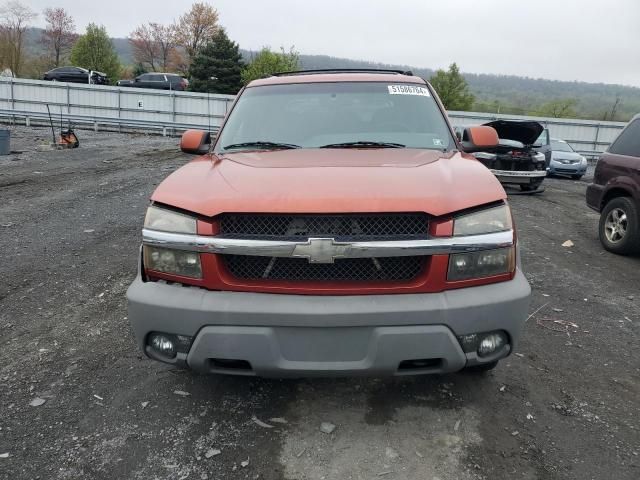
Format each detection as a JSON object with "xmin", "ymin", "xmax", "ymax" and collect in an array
[{"xmin": 71, "ymin": 23, "xmax": 121, "ymax": 81}]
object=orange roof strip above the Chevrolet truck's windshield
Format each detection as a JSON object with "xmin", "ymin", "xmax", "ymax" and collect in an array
[{"xmin": 248, "ymin": 70, "xmax": 426, "ymax": 87}]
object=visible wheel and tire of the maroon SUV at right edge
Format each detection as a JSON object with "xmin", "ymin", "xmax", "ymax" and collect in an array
[{"xmin": 598, "ymin": 197, "xmax": 640, "ymax": 255}]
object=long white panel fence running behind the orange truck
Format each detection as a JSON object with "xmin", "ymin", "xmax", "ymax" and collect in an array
[{"xmin": 0, "ymin": 77, "xmax": 625, "ymax": 156}]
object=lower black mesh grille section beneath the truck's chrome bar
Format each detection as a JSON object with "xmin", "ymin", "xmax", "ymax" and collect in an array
[{"xmin": 222, "ymin": 255, "xmax": 425, "ymax": 282}]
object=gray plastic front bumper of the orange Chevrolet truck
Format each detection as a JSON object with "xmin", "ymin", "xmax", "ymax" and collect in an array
[{"xmin": 127, "ymin": 270, "xmax": 531, "ymax": 376}]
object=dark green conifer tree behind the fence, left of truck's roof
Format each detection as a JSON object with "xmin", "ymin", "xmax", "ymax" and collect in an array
[{"xmin": 189, "ymin": 28, "xmax": 244, "ymax": 95}]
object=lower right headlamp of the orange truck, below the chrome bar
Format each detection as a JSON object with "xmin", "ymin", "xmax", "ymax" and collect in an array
[{"xmin": 447, "ymin": 247, "xmax": 516, "ymax": 281}]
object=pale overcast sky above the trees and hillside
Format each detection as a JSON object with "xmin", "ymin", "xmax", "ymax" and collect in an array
[{"xmin": 27, "ymin": 0, "xmax": 640, "ymax": 87}]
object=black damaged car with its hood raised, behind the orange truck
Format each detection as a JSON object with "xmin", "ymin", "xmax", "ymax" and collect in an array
[{"xmin": 462, "ymin": 120, "xmax": 547, "ymax": 192}]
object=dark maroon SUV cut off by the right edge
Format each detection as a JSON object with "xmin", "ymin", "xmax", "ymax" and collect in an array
[{"xmin": 587, "ymin": 115, "xmax": 640, "ymax": 255}]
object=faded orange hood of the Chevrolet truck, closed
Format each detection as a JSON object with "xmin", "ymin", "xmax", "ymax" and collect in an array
[{"xmin": 152, "ymin": 149, "xmax": 506, "ymax": 217}]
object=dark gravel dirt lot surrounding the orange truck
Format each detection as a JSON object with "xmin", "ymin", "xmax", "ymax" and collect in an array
[{"xmin": 0, "ymin": 128, "xmax": 640, "ymax": 480}]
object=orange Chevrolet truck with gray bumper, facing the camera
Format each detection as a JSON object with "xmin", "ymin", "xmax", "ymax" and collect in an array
[{"xmin": 127, "ymin": 70, "xmax": 530, "ymax": 376}]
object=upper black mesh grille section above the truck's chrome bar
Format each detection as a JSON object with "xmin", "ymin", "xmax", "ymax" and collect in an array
[{"xmin": 220, "ymin": 213, "xmax": 428, "ymax": 240}]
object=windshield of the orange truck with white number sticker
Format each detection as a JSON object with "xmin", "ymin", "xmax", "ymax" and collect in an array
[{"xmin": 216, "ymin": 82, "xmax": 455, "ymax": 152}]
